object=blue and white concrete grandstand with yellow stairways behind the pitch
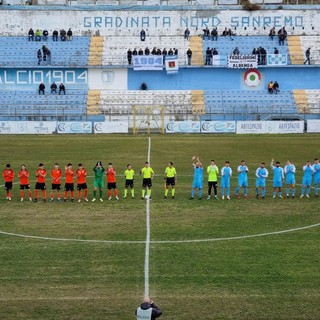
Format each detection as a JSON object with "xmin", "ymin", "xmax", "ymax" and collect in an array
[{"xmin": 0, "ymin": 2, "xmax": 320, "ymax": 129}]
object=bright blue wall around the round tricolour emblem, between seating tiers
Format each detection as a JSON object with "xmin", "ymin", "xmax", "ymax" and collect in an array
[{"xmin": 128, "ymin": 66, "xmax": 320, "ymax": 90}]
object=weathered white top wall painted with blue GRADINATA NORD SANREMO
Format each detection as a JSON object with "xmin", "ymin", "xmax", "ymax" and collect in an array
[{"xmin": 0, "ymin": 6, "xmax": 320, "ymax": 35}]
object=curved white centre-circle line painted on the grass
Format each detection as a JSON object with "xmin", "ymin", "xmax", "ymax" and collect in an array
[{"xmin": 0, "ymin": 222, "xmax": 320, "ymax": 244}]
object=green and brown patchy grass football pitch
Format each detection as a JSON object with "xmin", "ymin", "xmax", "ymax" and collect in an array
[{"xmin": 0, "ymin": 135, "xmax": 320, "ymax": 320}]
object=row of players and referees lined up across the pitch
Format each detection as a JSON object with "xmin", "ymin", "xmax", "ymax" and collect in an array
[{"xmin": 2, "ymin": 156, "xmax": 320, "ymax": 202}]
